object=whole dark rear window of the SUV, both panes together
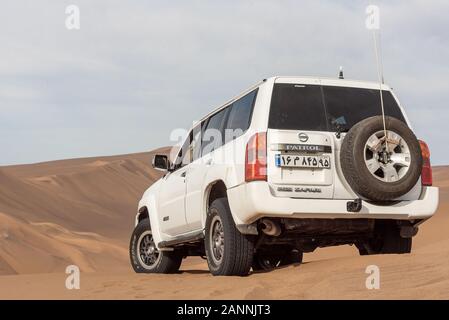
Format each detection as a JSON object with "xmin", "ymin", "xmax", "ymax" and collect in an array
[{"xmin": 268, "ymin": 84, "xmax": 405, "ymax": 131}]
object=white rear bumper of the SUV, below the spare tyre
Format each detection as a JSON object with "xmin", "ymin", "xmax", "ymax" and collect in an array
[{"xmin": 228, "ymin": 182, "xmax": 438, "ymax": 224}]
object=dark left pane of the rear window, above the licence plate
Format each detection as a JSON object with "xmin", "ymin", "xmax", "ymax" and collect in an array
[{"xmin": 268, "ymin": 84, "xmax": 327, "ymax": 131}]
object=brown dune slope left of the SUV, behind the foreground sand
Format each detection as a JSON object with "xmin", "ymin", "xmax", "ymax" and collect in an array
[{"xmin": 0, "ymin": 148, "xmax": 168, "ymax": 274}]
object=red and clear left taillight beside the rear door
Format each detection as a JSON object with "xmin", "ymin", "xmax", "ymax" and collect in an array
[{"xmin": 245, "ymin": 132, "xmax": 267, "ymax": 182}]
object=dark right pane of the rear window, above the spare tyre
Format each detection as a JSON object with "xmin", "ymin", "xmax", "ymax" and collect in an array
[{"xmin": 323, "ymin": 86, "xmax": 405, "ymax": 131}]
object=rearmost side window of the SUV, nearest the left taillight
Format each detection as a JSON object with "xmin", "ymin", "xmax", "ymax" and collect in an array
[{"xmin": 225, "ymin": 90, "xmax": 257, "ymax": 141}]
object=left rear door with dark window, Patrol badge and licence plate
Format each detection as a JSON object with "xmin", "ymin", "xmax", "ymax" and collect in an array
[{"xmin": 267, "ymin": 82, "xmax": 336, "ymax": 198}]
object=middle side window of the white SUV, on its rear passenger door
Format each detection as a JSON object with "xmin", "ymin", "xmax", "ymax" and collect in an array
[{"xmin": 201, "ymin": 107, "xmax": 229, "ymax": 155}]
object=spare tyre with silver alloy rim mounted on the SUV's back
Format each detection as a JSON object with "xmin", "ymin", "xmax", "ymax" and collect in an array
[{"xmin": 340, "ymin": 116, "xmax": 422, "ymax": 201}]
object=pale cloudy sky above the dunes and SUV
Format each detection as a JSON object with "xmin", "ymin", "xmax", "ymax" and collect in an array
[{"xmin": 0, "ymin": 0, "xmax": 449, "ymax": 165}]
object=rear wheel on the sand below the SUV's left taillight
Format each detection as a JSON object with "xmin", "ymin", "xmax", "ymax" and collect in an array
[{"xmin": 205, "ymin": 198, "xmax": 254, "ymax": 276}]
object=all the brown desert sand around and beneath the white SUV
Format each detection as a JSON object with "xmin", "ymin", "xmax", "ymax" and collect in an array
[{"xmin": 0, "ymin": 149, "xmax": 449, "ymax": 299}]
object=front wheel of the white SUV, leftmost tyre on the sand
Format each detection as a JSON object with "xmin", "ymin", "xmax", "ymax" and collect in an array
[{"xmin": 129, "ymin": 219, "xmax": 183, "ymax": 273}]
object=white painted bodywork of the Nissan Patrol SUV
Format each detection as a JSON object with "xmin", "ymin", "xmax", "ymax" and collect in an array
[{"xmin": 136, "ymin": 77, "xmax": 438, "ymax": 246}]
